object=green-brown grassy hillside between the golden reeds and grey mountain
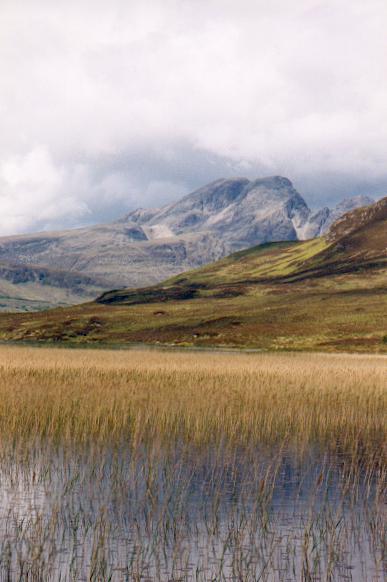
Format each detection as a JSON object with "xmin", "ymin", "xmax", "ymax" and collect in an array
[{"xmin": 0, "ymin": 198, "xmax": 387, "ymax": 353}]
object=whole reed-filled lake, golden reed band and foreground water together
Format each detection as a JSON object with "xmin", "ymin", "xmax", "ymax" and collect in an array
[{"xmin": 0, "ymin": 347, "xmax": 387, "ymax": 582}]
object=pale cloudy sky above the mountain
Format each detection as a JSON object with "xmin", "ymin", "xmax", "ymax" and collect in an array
[{"xmin": 0, "ymin": 0, "xmax": 387, "ymax": 234}]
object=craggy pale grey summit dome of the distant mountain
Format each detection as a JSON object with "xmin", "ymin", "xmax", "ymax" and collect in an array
[{"xmin": 126, "ymin": 176, "xmax": 310, "ymax": 250}]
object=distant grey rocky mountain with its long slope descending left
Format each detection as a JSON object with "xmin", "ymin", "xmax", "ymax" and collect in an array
[{"xmin": 0, "ymin": 176, "xmax": 376, "ymax": 310}]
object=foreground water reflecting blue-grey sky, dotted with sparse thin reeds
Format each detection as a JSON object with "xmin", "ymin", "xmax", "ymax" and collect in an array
[{"xmin": 0, "ymin": 443, "xmax": 385, "ymax": 582}]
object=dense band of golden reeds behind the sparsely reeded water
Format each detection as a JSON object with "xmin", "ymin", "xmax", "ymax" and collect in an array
[{"xmin": 0, "ymin": 348, "xmax": 387, "ymax": 449}]
